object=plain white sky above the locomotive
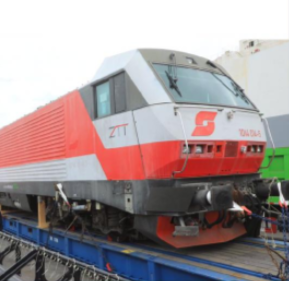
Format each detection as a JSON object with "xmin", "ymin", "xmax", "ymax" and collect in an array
[{"xmin": 0, "ymin": 0, "xmax": 289, "ymax": 127}]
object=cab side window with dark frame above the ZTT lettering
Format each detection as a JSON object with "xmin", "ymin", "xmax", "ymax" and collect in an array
[{"xmin": 94, "ymin": 73, "xmax": 127, "ymax": 118}]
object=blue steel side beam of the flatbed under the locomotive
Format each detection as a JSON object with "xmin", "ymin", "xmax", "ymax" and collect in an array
[{"xmin": 3, "ymin": 217, "xmax": 252, "ymax": 281}]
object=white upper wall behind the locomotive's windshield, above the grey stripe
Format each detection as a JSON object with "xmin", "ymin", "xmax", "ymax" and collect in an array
[{"xmin": 215, "ymin": 40, "xmax": 289, "ymax": 117}]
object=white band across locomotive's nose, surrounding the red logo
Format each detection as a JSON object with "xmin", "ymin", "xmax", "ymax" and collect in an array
[{"xmin": 134, "ymin": 104, "xmax": 266, "ymax": 144}]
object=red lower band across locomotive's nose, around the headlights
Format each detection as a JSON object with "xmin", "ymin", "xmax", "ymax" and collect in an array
[{"xmin": 141, "ymin": 141, "xmax": 265, "ymax": 179}]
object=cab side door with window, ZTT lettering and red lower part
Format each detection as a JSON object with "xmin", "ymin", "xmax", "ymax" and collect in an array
[{"xmin": 93, "ymin": 73, "xmax": 144, "ymax": 180}]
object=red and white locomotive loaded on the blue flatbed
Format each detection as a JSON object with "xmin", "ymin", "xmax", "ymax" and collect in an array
[{"xmin": 0, "ymin": 49, "xmax": 280, "ymax": 248}]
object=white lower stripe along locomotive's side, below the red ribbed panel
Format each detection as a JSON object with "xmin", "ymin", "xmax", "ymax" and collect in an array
[{"xmin": 0, "ymin": 155, "xmax": 106, "ymax": 182}]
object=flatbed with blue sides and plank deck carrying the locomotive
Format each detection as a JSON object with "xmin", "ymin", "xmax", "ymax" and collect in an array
[{"xmin": 3, "ymin": 215, "xmax": 284, "ymax": 281}]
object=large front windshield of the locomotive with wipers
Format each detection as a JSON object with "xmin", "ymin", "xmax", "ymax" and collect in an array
[{"xmin": 153, "ymin": 64, "xmax": 256, "ymax": 109}]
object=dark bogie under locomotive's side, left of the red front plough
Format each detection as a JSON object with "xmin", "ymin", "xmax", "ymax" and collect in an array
[{"xmin": 43, "ymin": 198, "xmax": 135, "ymax": 242}]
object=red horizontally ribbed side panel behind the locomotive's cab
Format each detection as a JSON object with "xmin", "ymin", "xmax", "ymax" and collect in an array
[{"xmin": 0, "ymin": 104, "xmax": 65, "ymax": 167}]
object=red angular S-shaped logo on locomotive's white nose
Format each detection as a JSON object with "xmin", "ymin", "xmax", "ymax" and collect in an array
[{"xmin": 192, "ymin": 111, "xmax": 217, "ymax": 136}]
